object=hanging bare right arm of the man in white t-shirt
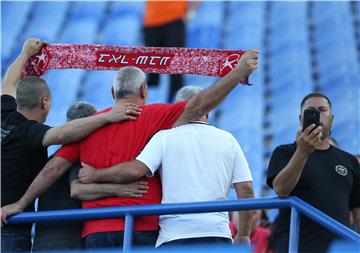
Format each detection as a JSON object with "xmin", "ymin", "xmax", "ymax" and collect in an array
[{"xmin": 234, "ymin": 181, "xmax": 255, "ymax": 243}]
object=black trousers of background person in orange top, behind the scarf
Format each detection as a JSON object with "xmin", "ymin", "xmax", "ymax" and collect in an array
[{"xmin": 144, "ymin": 19, "xmax": 185, "ymax": 102}]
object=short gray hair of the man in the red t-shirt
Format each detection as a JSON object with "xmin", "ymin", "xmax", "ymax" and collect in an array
[{"xmin": 113, "ymin": 66, "xmax": 147, "ymax": 99}]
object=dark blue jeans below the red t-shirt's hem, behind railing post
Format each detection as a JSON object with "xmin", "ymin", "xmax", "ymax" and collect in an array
[{"xmin": 85, "ymin": 231, "xmax": 159, "ymax": 249}]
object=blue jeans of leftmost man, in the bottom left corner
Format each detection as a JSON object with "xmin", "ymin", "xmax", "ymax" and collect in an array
[{"xmin": 1, "ymin": 227, "xmax": 31, "ymax": 253}]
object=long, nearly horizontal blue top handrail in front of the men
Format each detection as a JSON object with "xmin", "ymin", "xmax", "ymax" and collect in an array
[{"xmin": 9, "ymin": 198, "xmax": 291, "ymax": 223}]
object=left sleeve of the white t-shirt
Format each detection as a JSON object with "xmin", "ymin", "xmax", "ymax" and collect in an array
[{"xmin": 136, "ymin": 131, "xmax": 164, "ymax": 177}]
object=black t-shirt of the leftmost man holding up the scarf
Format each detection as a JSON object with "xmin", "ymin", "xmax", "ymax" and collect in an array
[{"xmin": 1, "ymin": 95, "xmax": 50, "ymax": 210}]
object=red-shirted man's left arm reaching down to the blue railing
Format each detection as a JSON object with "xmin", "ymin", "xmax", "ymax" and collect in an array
[{"xmin": 1, "ymin": 156, "xmax": 72, "ymax": 224}]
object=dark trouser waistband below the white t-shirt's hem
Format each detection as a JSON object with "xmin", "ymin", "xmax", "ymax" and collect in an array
[{"xmin": 160, "ymin": 237, "xmax": 232, "ymax": 248}]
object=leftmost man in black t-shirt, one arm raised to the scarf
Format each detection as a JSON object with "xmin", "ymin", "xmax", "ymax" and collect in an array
[{"xmin": 1, "ymin": 38, "xmax": 139, "ymax": 252}]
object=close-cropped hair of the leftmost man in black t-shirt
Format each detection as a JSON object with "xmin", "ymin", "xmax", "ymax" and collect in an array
[{"xmin": 16, "ymin": 76, "xmax": 51, "ymax": 110}]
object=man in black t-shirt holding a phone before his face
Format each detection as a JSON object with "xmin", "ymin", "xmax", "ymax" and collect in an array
[{"xmin": 267, "ymin": 93, "xmax": 360, "ymax": 252}]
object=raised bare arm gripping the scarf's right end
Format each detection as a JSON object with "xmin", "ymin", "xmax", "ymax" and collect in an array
[{"xmin": 174, "ymin": 50, "xmax": 259, "ymax": 126}]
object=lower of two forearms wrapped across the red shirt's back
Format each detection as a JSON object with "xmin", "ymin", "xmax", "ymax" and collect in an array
[{"xmin": 70, "ymin": 180, "xmax": 149, "ymax": 201}]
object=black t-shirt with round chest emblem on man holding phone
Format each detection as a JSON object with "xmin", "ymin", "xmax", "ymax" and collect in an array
[{"xmin": 267, "ymin": 143, "xmax": 360, "ymax": 251}]
